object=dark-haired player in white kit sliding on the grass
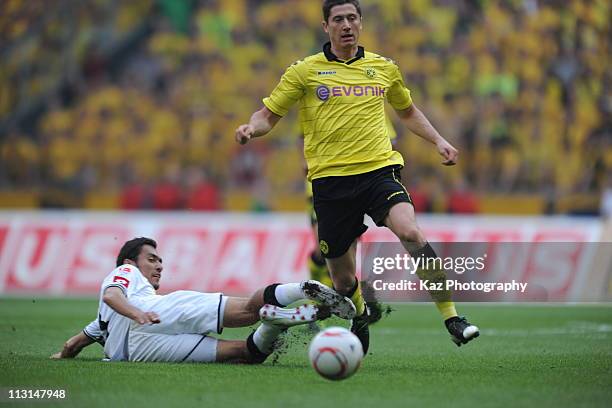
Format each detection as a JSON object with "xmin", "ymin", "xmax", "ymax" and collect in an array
[{"xmin": 51, "ymin": 238, "xmax": 355, "ymax": 363}]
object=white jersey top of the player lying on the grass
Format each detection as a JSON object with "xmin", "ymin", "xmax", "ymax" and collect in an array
[{"xmin": 96, "ymin": 264, "xmax": 155, "ymax": 360}]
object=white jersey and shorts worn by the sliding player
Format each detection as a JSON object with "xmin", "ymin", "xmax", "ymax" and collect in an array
[{"xmin": 83, "ymin": 264, "xmax": 227, "ymax": 362}]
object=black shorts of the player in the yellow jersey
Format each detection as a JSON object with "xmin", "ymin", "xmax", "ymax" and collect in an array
[{"xmin": 312, "ymin": 166, "xmax": 412, "ymax": 258}]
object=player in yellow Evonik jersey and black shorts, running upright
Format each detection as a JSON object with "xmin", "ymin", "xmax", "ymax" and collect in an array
[{"xmin": 236, "ymin": 0, "xmax": 479, "ymax": 353}]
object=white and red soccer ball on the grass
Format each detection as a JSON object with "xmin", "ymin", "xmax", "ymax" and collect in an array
[{"xmin": 308, "ymin": 327, "xmax": 363, "ymax": 380}]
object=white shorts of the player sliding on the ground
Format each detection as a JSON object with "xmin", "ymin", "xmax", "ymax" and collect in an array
[{"xmin": 128, "ymin": 290, "xmax": 227, "ymax": 363}]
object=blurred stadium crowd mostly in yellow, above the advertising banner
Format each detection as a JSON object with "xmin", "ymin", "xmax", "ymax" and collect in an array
[{"xmin": 0, "ymin": 0, "xmax": 612, "ymax": 212}]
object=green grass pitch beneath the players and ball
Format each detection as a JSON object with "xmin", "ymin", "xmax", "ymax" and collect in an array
[{"xmin": 0, "ymin": 298, "xmax": 612, "ymax": 408}]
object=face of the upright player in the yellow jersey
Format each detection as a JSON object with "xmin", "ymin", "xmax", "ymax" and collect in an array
[{"xmin": 323, "ymin": 4, "xmax": 363, "ymax": 48}]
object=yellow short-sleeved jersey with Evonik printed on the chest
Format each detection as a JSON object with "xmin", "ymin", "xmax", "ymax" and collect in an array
[{"xmin": 263, "ymin": 43, "xmax": 412, "ymax": 180}]
